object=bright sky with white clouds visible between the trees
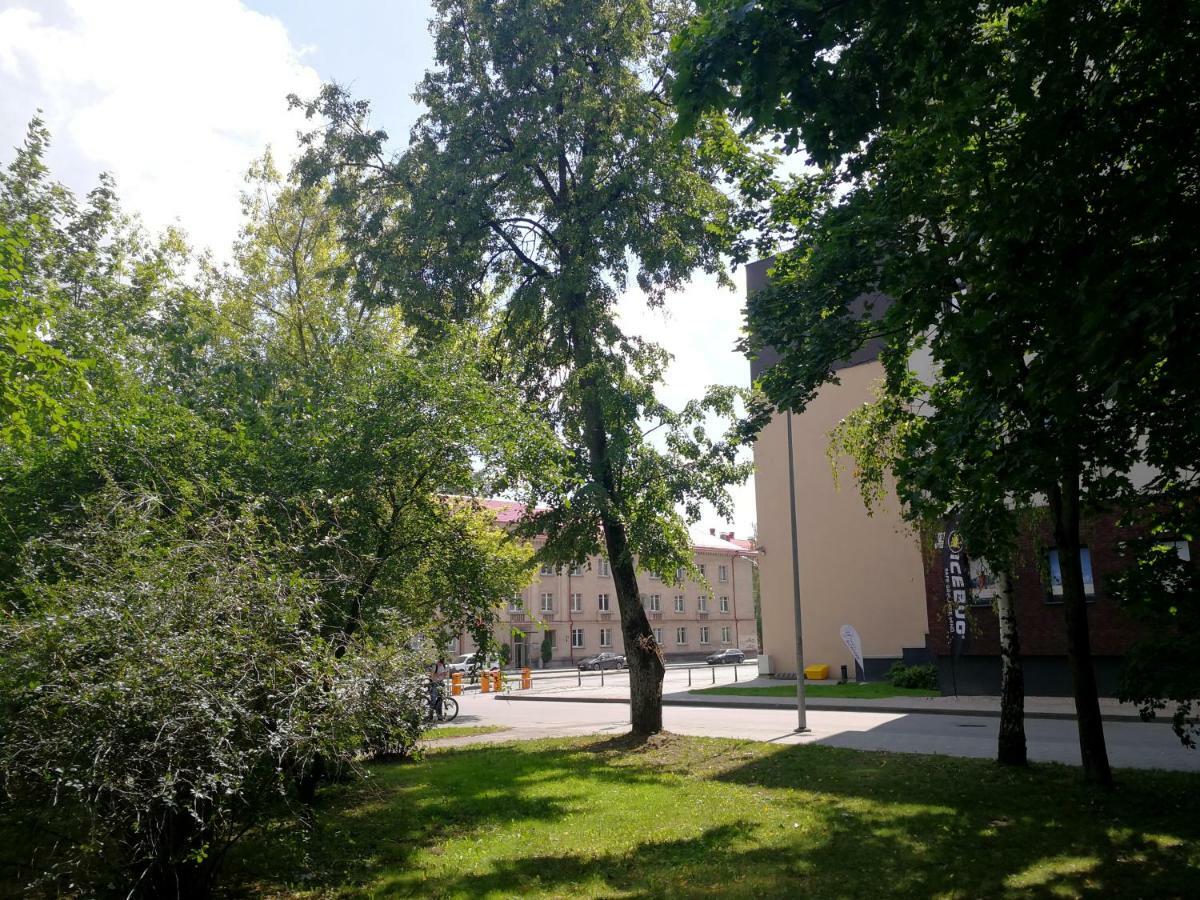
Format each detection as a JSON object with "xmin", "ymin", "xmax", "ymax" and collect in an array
[{"xmin": 0, "ymin": 0, "xmax": 755, "ymax": 536}]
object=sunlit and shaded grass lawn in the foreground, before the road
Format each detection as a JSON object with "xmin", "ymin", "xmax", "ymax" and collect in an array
[{"xmin": 226, "ymin": 734, "xmax": 1200, "ymax": 898}]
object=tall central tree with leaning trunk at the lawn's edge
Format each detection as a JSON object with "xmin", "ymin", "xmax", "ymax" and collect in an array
[{"xmin": 297, "ymin": 0, "xmax": 757, "ymax": 733}]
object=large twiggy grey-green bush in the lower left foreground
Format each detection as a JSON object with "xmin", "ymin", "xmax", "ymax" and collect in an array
[{"xmin": 0, "ymin": 498, "xmax": 422, "ymax": 896}]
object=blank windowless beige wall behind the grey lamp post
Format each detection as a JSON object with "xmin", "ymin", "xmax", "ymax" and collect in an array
[{"xmin": 755, "ymin": 361, "xmax": 928, "ymax": 673}]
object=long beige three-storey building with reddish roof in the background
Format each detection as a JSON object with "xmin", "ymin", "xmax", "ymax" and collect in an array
[{"xmin": 451, "ymin": 500, "xmax": 758, "ymax": 666}]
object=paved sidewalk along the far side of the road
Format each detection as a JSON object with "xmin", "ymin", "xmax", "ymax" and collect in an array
[{"xmin": 494, "ymin": 666, "xmax": 1171, "ymax": 724}]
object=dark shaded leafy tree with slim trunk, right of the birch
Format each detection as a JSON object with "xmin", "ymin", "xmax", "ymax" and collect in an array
[{"xmin": 676, "ymin": 0, "xmax": 1200, "ymax": 785}]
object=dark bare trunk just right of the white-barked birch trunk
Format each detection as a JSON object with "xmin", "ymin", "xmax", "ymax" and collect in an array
[{"xmin": 1050, "ymin": 460, "xmax": 1112, "ymax": 787}]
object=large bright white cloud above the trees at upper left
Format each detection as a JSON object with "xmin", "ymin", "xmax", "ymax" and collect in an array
[{"xmin": 0, "ymin": 0, "xmax": 320, "ymax": 253}]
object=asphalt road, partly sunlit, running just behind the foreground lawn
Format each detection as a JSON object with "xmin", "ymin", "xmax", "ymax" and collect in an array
[{"xmin": 455, "ymin": 695, "xmax": 1200, "ymax": 772}]
